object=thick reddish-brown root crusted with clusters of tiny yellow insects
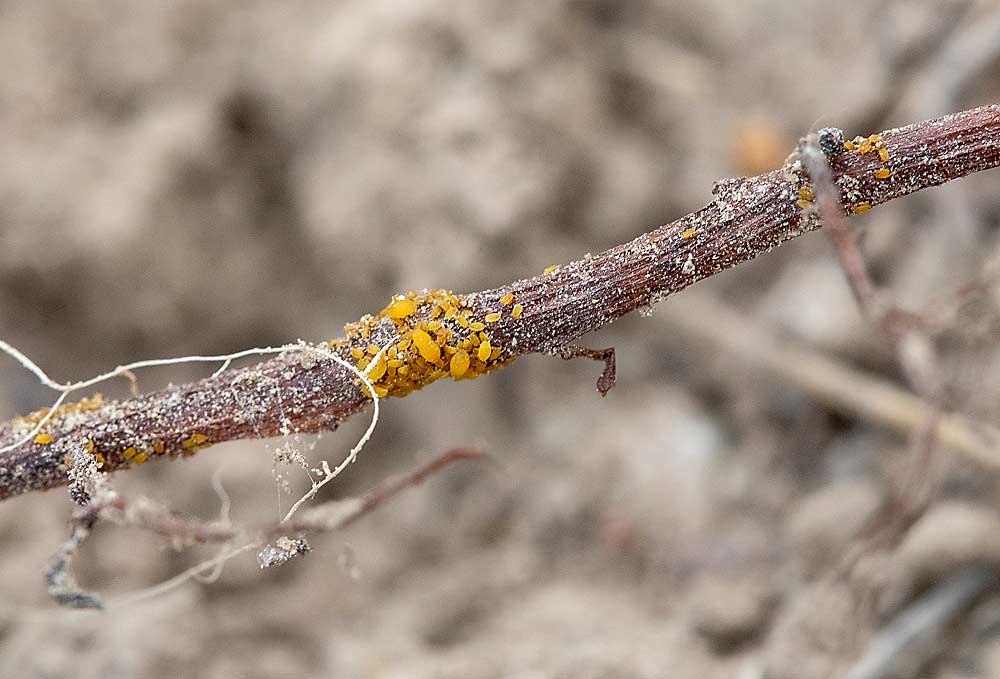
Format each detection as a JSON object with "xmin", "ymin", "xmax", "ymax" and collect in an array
[{"xmin": 0, "ymin": 105, "xmax": 1000, "ymax": 499}]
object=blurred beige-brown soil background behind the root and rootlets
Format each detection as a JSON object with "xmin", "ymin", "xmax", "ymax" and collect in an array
[{"xmin": 0, "ymin": 0, "xmax": 1000, "ymax": 679}]
